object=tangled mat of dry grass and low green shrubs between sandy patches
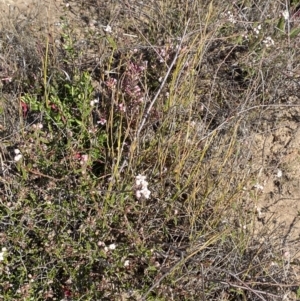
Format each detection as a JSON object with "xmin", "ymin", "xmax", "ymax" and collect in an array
[{"xmin": 0, "ymin": 1, "xmax": 299, "ymax": 301}]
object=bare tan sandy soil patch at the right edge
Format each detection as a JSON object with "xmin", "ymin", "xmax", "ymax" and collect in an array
[{"xmin": 251, "ymin": 100, "xmax": 300, "ymax": 260}]
